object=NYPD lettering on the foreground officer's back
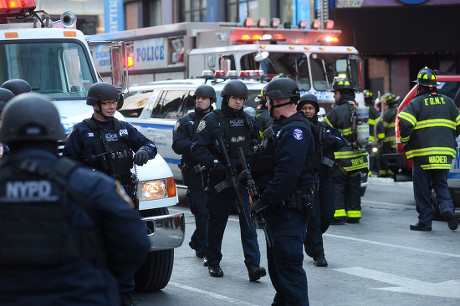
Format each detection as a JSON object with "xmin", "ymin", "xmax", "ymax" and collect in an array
[{"xmin": 2, "ymin": 180, "xmax": 58, "ymax": 202}]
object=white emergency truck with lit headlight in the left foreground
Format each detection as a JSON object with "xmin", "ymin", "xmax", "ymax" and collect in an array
[{"xmin": 0, "ymin": 0, "xmax": 185, "ymax": 291}]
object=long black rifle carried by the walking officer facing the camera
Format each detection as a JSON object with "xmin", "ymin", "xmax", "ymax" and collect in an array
[{"xmin": 216, "ymin": 137, "xmax": 251, "ymax": 228}]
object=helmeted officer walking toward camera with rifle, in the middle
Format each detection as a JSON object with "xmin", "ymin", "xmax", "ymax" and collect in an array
[{"xmin": 192, "ymin": 80, "xmax": 266, "ymax": 281}]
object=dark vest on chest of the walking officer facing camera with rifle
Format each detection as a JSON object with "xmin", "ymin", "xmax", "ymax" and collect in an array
[{"xmin": 213, "ymin": 109, "xmax": 252, "ymax": 158}]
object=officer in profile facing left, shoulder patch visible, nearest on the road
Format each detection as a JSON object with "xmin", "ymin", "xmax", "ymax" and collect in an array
[{"xmin": 252, "ymin": 78, "xmax": 318, "ymax": 305}]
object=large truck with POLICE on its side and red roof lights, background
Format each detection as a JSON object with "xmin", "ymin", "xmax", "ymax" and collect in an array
[{"xmin": 87, "ymin": 18, "xmax": 364, "ymax": 111}]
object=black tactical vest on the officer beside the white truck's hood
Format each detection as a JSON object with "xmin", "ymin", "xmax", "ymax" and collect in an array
[{"xmin": 83, "ymin": 118, "xmax": 133, "ymax": 185}]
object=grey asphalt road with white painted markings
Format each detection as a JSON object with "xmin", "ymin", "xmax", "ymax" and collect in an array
[{"xmin": 135, "ymin": 177, "xmax": 460, "ymax": 306}]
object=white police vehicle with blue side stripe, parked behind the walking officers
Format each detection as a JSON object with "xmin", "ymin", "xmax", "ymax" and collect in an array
[{"xmin": 120, "ymin": 78, "xmax": 267, "ymax": 183}]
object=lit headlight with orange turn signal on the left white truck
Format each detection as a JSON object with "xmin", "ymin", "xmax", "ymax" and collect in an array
[{"xmin": 137, "ymin": 177, "xmax": 176, "ymax": 201}]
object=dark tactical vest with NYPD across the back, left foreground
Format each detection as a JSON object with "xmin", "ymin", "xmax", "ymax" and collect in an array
[{"xmin": 0, "ymin": 158, "xmax": 106, "ymax": 266}]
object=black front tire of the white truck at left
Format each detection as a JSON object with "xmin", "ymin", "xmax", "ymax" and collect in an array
[{"xmin": 134, "ymin": 208, "xmax": 174, "ymax": 292}]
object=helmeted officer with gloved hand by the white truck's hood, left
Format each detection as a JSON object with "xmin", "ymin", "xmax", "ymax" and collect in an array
[{"xmin": 62, "ymin": 83, "xmax": 157, "ymax": 305}]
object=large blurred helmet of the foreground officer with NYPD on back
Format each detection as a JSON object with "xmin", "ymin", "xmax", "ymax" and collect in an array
[{"xmin": 0, "ymin": 93, "xmax": 65, "ymax": 143}]
